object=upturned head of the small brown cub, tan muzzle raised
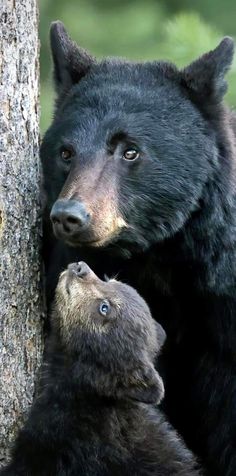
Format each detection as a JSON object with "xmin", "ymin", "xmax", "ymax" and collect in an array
[{"xmin": 52, "ymin": 262, "xmax": 165, "ymax": 403}]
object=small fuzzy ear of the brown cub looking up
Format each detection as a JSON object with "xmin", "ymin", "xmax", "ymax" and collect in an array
[{"xmin": 118, "ymin": 364, "xmax": 165, "ymax": 405}]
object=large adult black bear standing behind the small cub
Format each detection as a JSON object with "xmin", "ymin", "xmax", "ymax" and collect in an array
[{"xmin": 41, "ymin": 23, "xmax": 236, "ymax": 476}]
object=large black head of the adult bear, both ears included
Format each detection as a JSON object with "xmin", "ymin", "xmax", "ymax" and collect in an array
[{"xmin": 41, "ymin": 22, "xmax": 234, "ymax": 250}]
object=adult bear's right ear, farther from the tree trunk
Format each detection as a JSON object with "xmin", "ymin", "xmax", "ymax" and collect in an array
[{"xmin": 180, "ymin": 37, "xmax": 234, "ymax": 105}]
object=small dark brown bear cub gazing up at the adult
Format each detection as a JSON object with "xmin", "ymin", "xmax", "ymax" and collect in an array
[{"xmin": 0, "ymin": 263, "xmax": 199, "ymax": 476}]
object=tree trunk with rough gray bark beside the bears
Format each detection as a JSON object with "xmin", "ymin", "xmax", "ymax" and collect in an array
[{"xmin": 0, "ymin": 0, "xmax": 43, "ymax": 463}]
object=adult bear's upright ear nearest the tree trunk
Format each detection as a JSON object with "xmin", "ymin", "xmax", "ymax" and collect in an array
[{"xmin": 50, "ymin": 21, "xmax": 95, "ymax": 94}]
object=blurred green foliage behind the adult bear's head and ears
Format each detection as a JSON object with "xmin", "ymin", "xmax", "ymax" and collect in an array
[{"xmin": 40, "ymin": 0, "xmax": 236, "ymax": 132}]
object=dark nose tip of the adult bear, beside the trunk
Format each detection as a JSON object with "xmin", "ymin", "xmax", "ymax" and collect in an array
[{"xmin": 50, "ymin": 200, "xmax": 90, "ymax": 236}]
